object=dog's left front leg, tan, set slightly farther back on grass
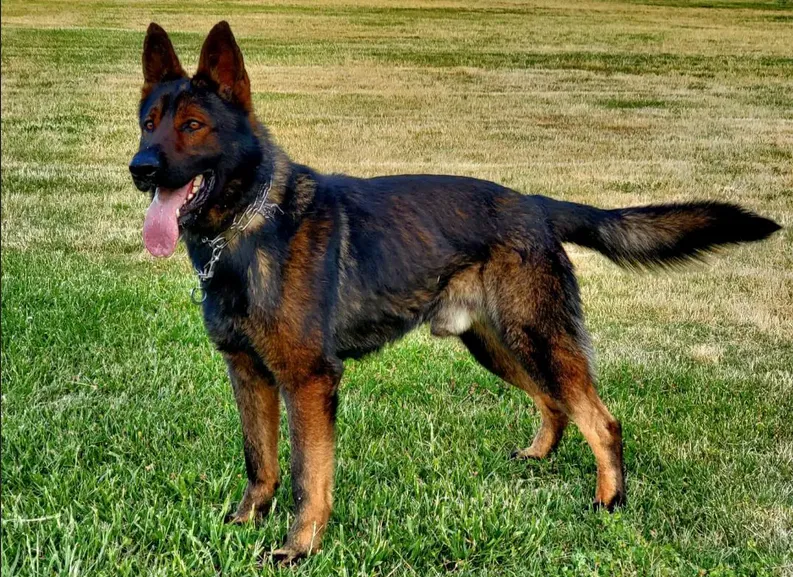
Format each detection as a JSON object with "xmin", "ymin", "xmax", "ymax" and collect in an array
[{"xmin": 225, "ymin": 353, "xmax": 279, "ymax": 523}]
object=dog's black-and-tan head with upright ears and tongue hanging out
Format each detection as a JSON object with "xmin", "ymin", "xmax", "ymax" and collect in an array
[{"xmin": 129, "ymin": 22, "xmax": 262, "ymax": 256}]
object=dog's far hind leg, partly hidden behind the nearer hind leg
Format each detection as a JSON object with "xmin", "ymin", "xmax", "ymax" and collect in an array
[{"xmin": 460, "ymin": 323, "xmax": 568, "ymax": 459}]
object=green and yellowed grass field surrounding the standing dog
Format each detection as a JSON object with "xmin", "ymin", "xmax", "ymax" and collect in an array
[{"xmin": 2, "ymin": 0, "xmax": 793, "ymax": 576}]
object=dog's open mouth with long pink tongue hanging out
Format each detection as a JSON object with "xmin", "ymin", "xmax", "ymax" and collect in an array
[{"xmin": 143, "ymin": 171, "xmax": 215, "ymax": 257}]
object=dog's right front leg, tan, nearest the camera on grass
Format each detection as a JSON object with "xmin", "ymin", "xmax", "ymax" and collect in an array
[{"xmin": 273, "ymin": 363, "xmax": 341, "ymax": 563}]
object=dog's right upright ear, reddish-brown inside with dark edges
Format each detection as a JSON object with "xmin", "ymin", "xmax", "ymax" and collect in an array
[{"xmin": 196, "ymin": 20, "xmax": 251, "ymax": 111}]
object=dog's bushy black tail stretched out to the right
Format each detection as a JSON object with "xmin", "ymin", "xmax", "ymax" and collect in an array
[{"xmin": 541, "ymin": 197, "xmax": 781, "ymax": 268}]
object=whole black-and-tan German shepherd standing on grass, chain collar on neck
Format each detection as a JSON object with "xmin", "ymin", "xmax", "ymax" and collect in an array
[{"xmin": 129, "ymin": 22, "xmax": 779, "ymax": 562}]
